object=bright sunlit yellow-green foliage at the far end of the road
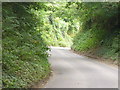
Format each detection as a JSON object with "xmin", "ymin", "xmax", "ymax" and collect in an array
[{"xmin": 38, "ymin": 2, "xmax": 79, "ymax": 47}]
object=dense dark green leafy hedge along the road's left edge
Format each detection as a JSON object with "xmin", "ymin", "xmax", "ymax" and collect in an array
[{"xmin": 2, "ymin": 3, "xmax": 50, "ymax": 88}]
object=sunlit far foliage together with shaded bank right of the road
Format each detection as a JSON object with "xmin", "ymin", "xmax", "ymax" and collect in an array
[{"xmin": 42, "ymin": 2, "xmax": 120, "ymax": 60}]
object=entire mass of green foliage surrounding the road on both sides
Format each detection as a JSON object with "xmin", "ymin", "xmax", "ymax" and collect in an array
[{"xmin": 2, "ymin": 2, "xmax": 120, "ymax": 88}]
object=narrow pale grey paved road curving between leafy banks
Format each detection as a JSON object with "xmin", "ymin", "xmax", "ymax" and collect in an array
[{"xmin": 45, "ymin": 47, "xmax": 118, "ymax": 88}]
